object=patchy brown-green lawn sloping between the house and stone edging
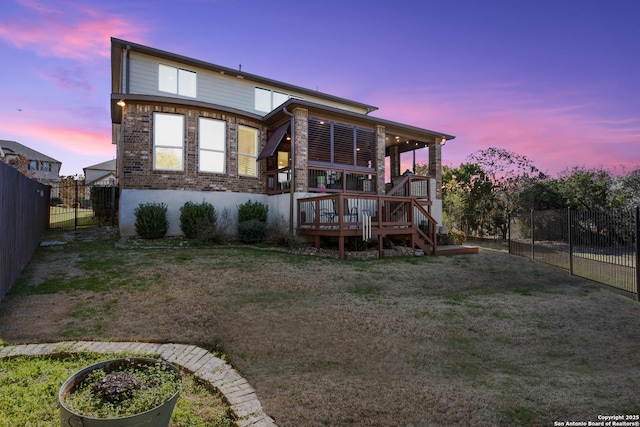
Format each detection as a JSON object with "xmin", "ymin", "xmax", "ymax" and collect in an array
[{"xmin": 0, "ymin": 232, "xmax": 640, "ymax": 427}]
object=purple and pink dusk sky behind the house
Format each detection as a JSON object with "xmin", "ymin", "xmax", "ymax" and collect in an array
[{"xmin": 0, "ymin": 0, "xmax": 640, "ymax": 176}]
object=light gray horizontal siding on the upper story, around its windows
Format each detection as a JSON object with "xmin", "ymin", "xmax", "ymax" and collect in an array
[{"xmin": 123, "ymin": 52, "xmax": 366, "ymax": 115}]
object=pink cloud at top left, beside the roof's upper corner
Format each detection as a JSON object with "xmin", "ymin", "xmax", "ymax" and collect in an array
[{"xmin": 0, "ymin": 0, "xmax": 145, "ymax": 61}]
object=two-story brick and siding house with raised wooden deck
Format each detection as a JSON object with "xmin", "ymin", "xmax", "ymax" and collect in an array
[{"xmin": 111, "ymin": 38, "xmax": 454, "ymax": 255}]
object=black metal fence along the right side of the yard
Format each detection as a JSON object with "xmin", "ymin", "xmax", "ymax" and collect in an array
[{"xmin": 509, "ymin": 207, "xmax": 640, "ymax": 300}]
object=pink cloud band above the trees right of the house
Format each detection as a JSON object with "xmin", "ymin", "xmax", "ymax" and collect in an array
[{"xmin": 374, "ymin": 88, "xmax": 640, "ymax": 176}]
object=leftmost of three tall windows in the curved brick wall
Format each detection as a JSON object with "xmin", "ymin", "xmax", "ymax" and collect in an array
[{"xmin": 153, "ymin": 113, "xmax": 184, "ymax": 171}]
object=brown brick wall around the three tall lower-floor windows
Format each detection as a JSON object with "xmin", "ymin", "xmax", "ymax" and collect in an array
[{"xmin": 117, "ymin": 102, "xmax": 267, "ymax": 194}]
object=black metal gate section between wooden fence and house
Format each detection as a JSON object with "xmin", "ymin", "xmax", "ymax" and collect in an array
[{"xmin": 49, "ymin": 180, "xmax": 118, "ymax": 230}]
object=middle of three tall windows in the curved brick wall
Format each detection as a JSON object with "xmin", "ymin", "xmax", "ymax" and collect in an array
[{"xmin": 198, "ymin": 117, "xmax": 227, "ymax": 173}]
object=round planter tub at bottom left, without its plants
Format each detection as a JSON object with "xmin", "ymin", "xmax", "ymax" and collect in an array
[{"xmin": 58, "ymin": 357, "xmax": 181, "ymax": 427}]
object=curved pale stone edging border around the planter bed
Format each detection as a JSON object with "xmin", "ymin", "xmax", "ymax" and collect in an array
[{"xmin": 0, "ymin": 341, "xmax": 277, "ymax": 427}]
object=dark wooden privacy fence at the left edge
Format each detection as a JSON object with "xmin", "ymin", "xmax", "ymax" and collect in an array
[{"xmin": 0, "ymin": 162, "xmax": 49, "ymax": 300}]
